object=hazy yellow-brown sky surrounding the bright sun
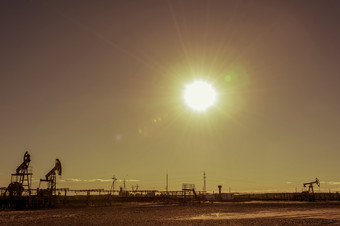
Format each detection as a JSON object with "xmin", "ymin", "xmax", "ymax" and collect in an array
[{"xmin": 0, "ymin": 0, "xmax": 340, "ymax": 191}]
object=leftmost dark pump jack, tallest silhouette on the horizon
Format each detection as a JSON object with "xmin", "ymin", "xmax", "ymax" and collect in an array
[{"xmin": 5, "ymin": 151, "xmax": 32, "ymax": 197}]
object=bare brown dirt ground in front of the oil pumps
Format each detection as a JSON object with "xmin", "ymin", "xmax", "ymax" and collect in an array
[{"xmin": 0, "ymin": 202, "xmax": 340, "ymax": 225}]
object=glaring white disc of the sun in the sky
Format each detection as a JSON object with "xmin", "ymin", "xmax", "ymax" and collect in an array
[{"xmin": 183, "ymin": 80, "xmax": 217, "ymax": 112}]
